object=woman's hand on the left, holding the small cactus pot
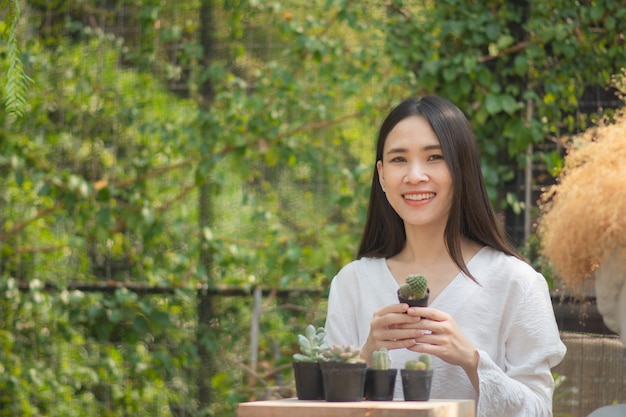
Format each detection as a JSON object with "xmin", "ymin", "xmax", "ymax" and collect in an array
[{"xmin": 361, "ymin": 303, "xmax": 424, "ymax": 364}]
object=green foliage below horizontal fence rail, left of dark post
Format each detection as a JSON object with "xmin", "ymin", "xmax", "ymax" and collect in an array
[{"xmin": 0, "ymin": 278, "xmax": 194, "ymax": 416}]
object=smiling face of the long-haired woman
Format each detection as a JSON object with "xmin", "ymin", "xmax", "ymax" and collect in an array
[{"xmin": 376, "ymin": 116, "xmax": 453, "ymax": 227}]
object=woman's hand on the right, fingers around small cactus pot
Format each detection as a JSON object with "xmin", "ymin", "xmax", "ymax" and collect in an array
[{"xmin": 406, "ymin": 307, "xmax": 479, "ymax": 392}]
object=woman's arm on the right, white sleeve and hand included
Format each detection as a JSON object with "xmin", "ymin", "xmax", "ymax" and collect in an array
[{"xmin": 409, "ymin": 277, "xmax": 565, "ymax": 416}]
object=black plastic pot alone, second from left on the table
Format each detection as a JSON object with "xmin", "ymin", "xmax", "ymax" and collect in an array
[{"xmin": 320, "ymin": 362, "xmax": 367, "ymax": 402}]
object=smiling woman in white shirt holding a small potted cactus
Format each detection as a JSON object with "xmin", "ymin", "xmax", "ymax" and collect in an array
[{"xmin": 326, "ymin": 97, "xmax": 565, "ymax": 417}]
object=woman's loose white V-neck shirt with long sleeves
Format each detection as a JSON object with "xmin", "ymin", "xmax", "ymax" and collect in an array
[{"xmin": 326, "ymin": 247, "xmax": 566, "ymax": 417}]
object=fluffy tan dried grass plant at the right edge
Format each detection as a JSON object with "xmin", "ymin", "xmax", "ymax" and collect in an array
[{"xmin": 538, "ymin": 77, "xmax": 626, "ymax": 288}]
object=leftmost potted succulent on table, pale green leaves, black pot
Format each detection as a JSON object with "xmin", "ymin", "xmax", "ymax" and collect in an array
[{"xmin": 292, "ymin": 324, "xmax": 326, "ymax": 400}]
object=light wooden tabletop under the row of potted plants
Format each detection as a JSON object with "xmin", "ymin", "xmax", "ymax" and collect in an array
[{"xmin": 237, "ymin": 398, "xmax": 476, "ymax": 417}]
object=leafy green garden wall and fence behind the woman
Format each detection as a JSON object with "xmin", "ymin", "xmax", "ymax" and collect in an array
[{"xmin": 0, "ymin": 0, "xmax": 626, "ymax": 416}]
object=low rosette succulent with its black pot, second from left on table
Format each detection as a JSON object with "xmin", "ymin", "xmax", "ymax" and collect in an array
[{"xmin": 320, "ymin": 345, "xmax": 367, "ymax": 401}]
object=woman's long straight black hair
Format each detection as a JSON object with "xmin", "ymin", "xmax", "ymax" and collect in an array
[{"xmin": 357, "ymin": 96, "xmax": 519, "ymax": 280}]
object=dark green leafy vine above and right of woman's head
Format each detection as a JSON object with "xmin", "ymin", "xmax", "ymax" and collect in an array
[{"xmin": 386, "ymin": 0, "xmax": 626, "ymax": 203}]
